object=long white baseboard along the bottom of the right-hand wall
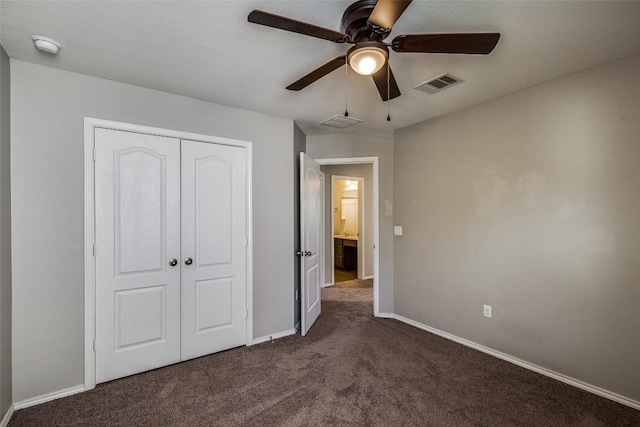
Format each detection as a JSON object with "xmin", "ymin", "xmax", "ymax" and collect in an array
[{"xmin": 390, "ymin": 314, "xmax": 640, "ymax": 410}]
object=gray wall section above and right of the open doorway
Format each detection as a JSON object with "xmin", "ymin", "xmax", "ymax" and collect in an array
[{"xmin": 307, "ymin": 133, "xmax": 393, "ymax": 313}]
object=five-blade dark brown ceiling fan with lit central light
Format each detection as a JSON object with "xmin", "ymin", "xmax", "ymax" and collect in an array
[{"xmin": 248, "ymin": 0, "xmax": 500, "ymax": 101}]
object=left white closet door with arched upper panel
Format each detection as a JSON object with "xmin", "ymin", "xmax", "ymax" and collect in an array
[{"xmin": 95, "ymin": 129, "xmax": 181, "ymax": 382}]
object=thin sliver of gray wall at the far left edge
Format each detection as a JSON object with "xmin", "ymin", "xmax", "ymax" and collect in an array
[{"xmin": 0, "ymin": 46, "xmax": 13, "ymax": 420}]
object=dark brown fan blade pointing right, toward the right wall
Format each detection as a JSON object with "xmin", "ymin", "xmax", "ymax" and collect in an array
[{"xmin": 391, "ymin": 33, "xmax": 500, "ymax": 55}]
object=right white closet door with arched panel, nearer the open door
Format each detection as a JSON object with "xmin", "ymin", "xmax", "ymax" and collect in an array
[{"xmin": 181, "ymin": 140, "xmax": 247, "ymax": 360}]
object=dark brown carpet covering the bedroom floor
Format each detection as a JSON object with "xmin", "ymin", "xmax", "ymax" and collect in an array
[{"xmin": 9, "ymin": 288, "xmax": 640, "ymax": 427}]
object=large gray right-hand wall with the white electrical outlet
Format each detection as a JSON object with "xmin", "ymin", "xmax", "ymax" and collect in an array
[{"xmin": 394, "ymin": 51, "xmax": 640, "ymax": 401}]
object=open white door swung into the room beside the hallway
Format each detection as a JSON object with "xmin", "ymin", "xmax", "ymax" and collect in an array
[{"xmin": 298, "ymin": 153, "xmax": 323, "ymax": 336}]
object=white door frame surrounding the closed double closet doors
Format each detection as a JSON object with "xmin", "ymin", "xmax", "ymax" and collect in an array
[{"xmin": 84, "ymin": 117, "xmax": 253, "ymax": 390}]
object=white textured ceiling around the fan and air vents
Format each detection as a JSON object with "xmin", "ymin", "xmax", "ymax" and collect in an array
[{"xmin": 0, "ymin": 0, "xmax": 640, "ymax": 134}]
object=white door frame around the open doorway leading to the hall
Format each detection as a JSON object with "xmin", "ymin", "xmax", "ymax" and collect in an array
[{"xmin": 315, "ymin": 156, "xmax": 380, "ymax": 317}]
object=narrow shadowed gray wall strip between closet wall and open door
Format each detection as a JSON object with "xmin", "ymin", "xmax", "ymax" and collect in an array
[{"xmin": 291, "ymin": 123, "xmax": 307, "ymax": 325}]
